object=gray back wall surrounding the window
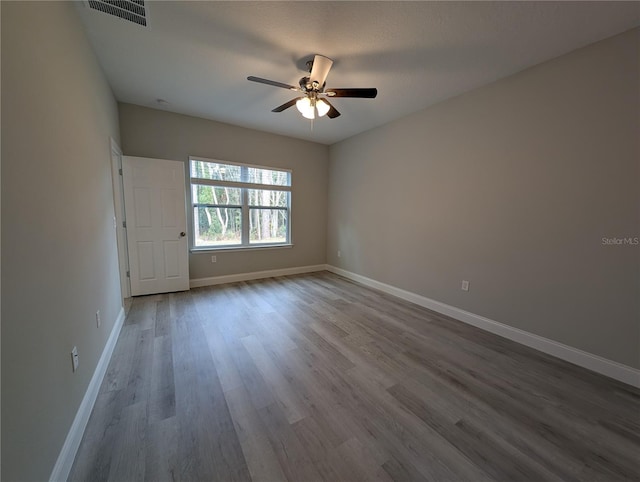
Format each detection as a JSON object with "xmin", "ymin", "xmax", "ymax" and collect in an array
[{"xmin": 119, "ymin": 104, "xmax": 329, "ymax": 279}]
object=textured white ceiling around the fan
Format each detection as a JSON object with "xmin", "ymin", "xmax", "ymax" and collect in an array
[{"xmin": 77, "ymin": 1, "xmax": 640, "ymax": 144}]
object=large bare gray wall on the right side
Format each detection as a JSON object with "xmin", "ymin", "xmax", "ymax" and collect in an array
[{"xmin": 327, "ymin": 29, "xmax": 640, "ymax": 368}]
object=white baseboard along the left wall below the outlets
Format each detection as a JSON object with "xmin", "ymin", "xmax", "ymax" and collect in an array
[{"xmin": 49, "ymin": 308, "xmax": 125, "ymax": 482}]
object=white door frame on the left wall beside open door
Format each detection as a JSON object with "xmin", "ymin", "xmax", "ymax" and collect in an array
[{"xmin": 110, "ymin": 138, "xmax": 131, "ymax": 298}]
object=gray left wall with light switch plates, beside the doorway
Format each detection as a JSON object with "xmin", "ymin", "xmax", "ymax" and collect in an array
[{"xmin": 1, "ymin": 2, "xmax": 122, "ymax": 481}]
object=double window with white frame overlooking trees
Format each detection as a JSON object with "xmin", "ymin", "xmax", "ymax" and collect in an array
[{"xmin": 189, "ymin": 158, "xmax": 291, "ymax": 249}]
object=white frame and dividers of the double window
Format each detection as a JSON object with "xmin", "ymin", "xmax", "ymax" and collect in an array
[{"xmin": 187, "ymin": 156, "xmax": 293, "ymax": 252}]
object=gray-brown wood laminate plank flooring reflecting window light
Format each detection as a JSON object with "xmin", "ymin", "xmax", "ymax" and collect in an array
[{"xmin": 70, "ymin": 272, "xmax": 640, "ymax": 482}]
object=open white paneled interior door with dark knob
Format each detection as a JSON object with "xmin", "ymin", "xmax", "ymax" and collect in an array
[{"xmin": 122, "ymin": 156, "xmax": 189, "ymax": 296}]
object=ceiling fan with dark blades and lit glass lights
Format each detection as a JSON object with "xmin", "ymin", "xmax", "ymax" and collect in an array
[{"xmin": 247, "ymin": 55, "xmax": 378, "ymax": 119}]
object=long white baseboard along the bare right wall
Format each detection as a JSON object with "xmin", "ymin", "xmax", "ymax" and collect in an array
[{"xmin": 326, "ymin": 265, "xmax": 640, "ymax": 388}]
